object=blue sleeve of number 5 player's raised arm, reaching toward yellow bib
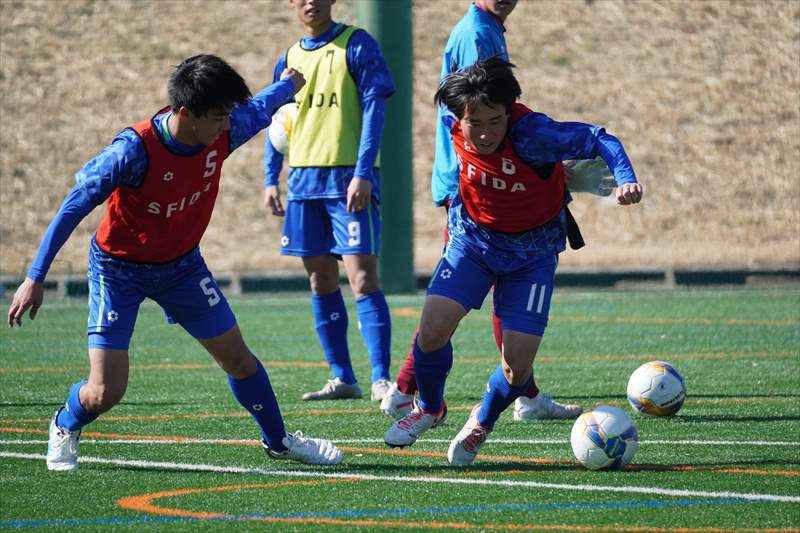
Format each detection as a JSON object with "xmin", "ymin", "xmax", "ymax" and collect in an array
[{"xmin": 230, "ymin": 75, "xmax": 294, "ymax": 152}]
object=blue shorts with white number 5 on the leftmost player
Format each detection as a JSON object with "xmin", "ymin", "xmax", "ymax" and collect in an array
[{"xmin": 87, "ymin": 237, "xmax": 236, "ymax": 350}]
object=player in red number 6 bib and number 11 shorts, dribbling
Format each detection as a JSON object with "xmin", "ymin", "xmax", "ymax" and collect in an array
[{"xmin": 384, "ymin": 57, "xmax": 642, "ymax": 465}]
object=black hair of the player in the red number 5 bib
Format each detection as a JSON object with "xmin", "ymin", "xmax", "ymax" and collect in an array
[{"xmin": 167, "ymin": 54, "xmax": 251, "ymax": 116}]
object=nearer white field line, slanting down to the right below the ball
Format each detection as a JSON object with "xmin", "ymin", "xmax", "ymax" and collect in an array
[{"xmin": 0, "ymin": 452, "xmax": 800, "ymax": 503}]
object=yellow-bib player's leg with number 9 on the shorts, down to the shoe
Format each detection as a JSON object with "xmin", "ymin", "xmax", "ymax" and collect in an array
[{"xmin": 326, "ymin": 199, "xmax": 392, "ymax": 401}]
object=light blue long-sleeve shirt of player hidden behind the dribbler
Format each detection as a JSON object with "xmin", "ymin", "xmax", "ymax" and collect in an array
[{"xmin": 431, "ymin": 5, "xmax": 508, "ymax": 205}]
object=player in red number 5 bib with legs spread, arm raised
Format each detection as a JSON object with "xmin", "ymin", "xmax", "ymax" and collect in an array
[{"xmin": 8, "ymin": 55, "xmax": 342, "ymax": 470}]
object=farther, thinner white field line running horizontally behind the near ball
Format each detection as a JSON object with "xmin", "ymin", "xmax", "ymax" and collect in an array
[{"xmin": 0, "ymin": 437, "xmax": 800, "ymax": 447}]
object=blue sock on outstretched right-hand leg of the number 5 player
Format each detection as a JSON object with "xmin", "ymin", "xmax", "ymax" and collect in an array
[{"xmin": 228, "ymin": 358, "xmax": 286, "ymax": 452}]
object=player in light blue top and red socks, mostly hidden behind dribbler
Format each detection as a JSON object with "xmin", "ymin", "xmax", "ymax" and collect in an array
[{"xmin": 381, "ymin": 0, "xmax": 584, "ymax": 420}]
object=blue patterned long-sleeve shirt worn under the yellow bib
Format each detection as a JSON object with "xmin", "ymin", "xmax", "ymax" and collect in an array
[{"xmin": 264, "ymin": 23, "xmax": 395, "ymax": 200}]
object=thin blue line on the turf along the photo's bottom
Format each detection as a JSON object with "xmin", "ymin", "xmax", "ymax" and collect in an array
[{"xmin": 0, "ymin": 498, "xmax": 752, "ymax": 528}]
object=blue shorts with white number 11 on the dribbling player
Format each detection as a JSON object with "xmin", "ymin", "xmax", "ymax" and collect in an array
[{"xmin": 428, "ymin": 240, "xmax": 558, "ymax": 337}]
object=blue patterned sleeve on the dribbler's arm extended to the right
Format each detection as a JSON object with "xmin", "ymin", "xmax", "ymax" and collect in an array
[{"xmin": 511, "ymin": 113, "xmax": 637, "ymax": 185}]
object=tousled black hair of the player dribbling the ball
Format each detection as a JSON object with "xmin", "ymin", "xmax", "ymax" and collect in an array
[{"xmin": 433, "ymin": 56, "xmax": 522, "ymax": 119}]
